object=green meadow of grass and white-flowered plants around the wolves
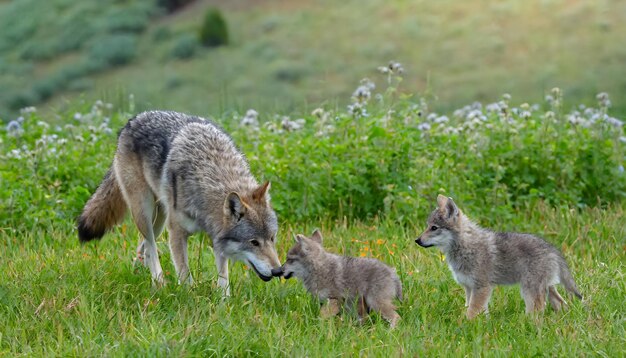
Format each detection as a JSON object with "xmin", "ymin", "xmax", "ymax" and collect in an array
[{"xmin": 0, "ymin": 72, "xmax": 626, "ymax": 357}]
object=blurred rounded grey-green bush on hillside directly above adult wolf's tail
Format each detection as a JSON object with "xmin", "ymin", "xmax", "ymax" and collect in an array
[{"xmin": 88, "ymin": 34, "xmax": 137, "ymax": 67}]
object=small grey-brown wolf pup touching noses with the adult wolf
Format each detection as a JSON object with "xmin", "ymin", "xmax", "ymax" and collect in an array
[{"xmin": 282, "ymin": 230, "xmax": 402, "ymax": 328}]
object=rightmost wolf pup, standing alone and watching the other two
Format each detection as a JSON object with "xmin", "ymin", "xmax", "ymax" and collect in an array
[{"xmin": 415, "ymin": 195, "xmax": 582, "ymax": 319}]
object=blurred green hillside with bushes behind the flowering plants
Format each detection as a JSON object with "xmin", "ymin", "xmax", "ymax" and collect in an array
[{"xmin": 0, "ymin": 0, "xmax": 626, "ymax": 121}]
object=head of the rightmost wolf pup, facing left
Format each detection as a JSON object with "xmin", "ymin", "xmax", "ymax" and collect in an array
[{"xmin": 415, "ymin": 194, "xmax": 463, "ymax": 251}]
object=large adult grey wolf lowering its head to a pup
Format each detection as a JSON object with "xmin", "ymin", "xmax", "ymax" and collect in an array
[{"xmin": 78, "ymin": 111, "xmax": 280, "ymax": 295}]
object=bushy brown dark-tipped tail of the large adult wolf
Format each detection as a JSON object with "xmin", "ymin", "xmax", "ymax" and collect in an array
[{"xmin": 78, "ymin": 167, "xmax": 126, "ymax": 242}]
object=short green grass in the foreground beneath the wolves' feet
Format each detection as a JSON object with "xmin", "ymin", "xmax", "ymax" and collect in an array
[{"xmin": 0, "ymin": 203, "xmax": 626, "ymax": 357}]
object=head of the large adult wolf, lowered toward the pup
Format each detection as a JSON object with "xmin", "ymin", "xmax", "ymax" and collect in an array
[{"xmin": 215, "ymin": 182, "xmax": 280, "ymax": 281}]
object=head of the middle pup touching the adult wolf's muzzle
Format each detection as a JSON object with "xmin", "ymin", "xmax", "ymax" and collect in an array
[{"xmin": 282, "ymin": 230, "xmax": 324, "ymax": 280}]
